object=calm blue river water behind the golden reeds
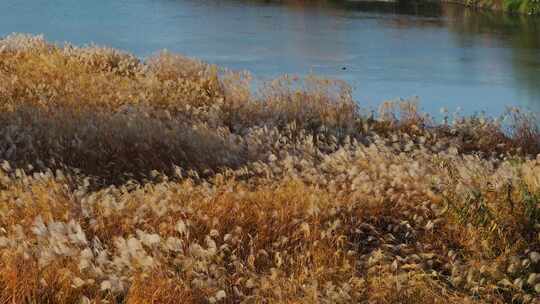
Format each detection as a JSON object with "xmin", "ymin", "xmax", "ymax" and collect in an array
[{"xmin": 0, "ymin": 0, "xmax": 540, "ymax": 115}]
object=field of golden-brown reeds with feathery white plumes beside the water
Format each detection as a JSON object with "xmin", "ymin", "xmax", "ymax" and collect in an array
[{"xmin": 0, "ymin": 35, "xmax": 540, "ymax": 304}]
